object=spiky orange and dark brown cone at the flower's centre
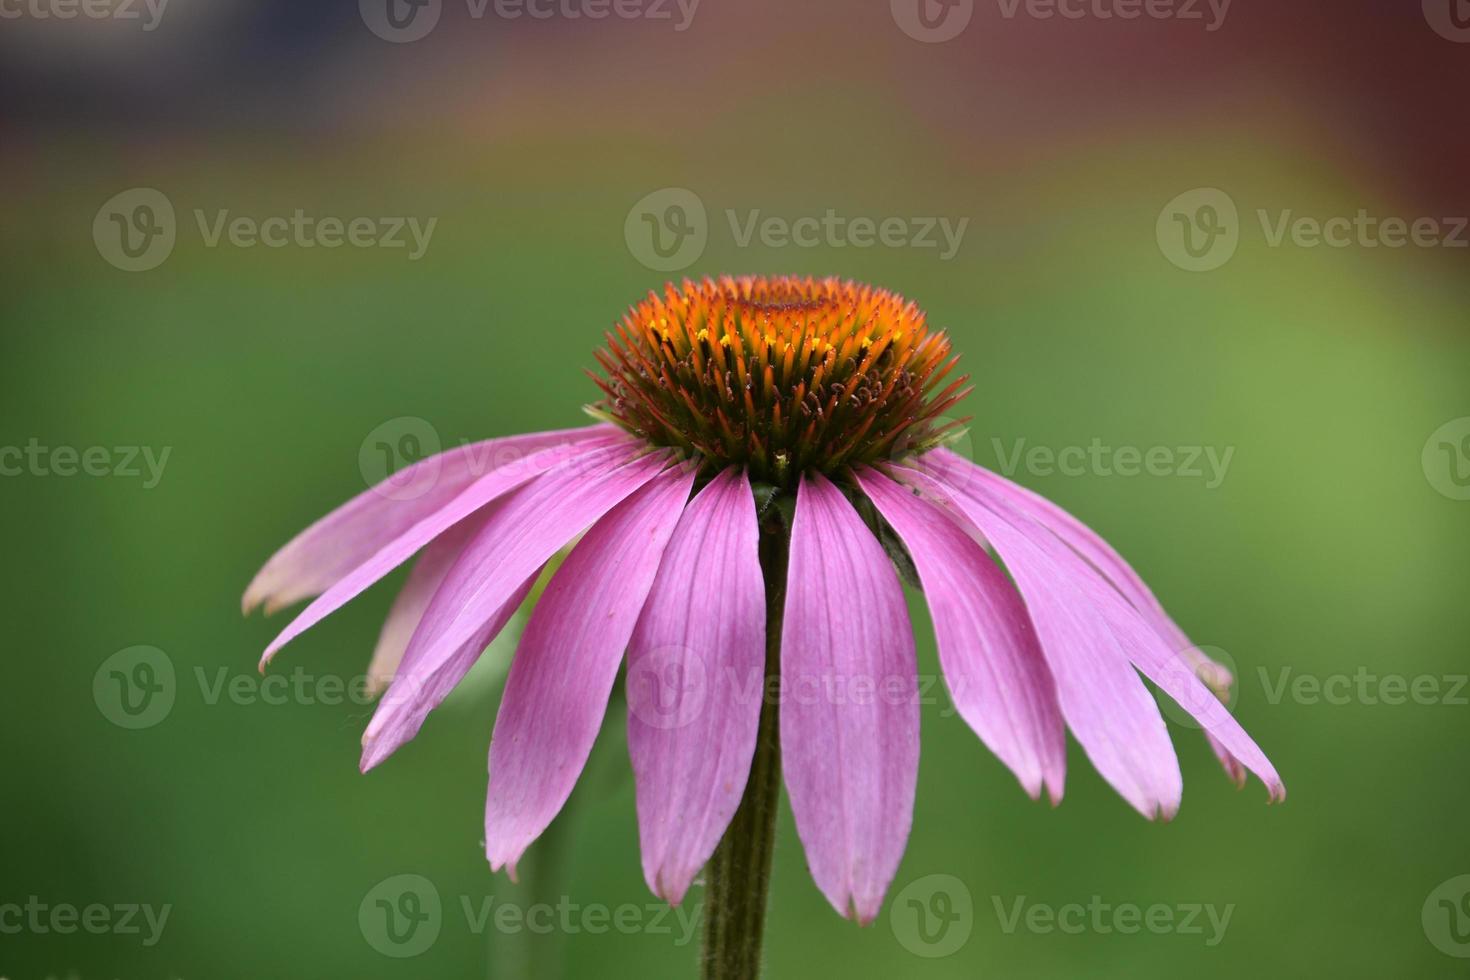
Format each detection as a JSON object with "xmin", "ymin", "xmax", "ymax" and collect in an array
[{"xmin": 592, "ymin": 276, "xmax": 969, "ymax": 486}]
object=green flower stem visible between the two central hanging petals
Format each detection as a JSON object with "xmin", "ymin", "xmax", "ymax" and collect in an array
[{"xmin": 703, "ymin": 522, "xmax": 786, "ymax": 980}]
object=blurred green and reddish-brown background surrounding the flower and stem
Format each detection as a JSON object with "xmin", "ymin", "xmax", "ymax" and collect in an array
[{"xmin": 0, "ymin": 0, "xmax": 1470, "ymax": 980}]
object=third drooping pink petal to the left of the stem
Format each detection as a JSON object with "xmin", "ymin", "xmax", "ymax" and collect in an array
[{"xmin": 362, "ymin": 444, "xmax": 667, "ymax": 771}]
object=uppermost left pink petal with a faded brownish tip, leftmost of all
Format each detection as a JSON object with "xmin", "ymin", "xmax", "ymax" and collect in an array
[{"xmin": 241, "ymin": 425, "xmax": 614, "ymax": 613}]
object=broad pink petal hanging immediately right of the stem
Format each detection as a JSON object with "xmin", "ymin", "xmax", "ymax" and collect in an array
[{"xmin": 781, "ymin": 475, "xmax": 919, "ymax": 924}]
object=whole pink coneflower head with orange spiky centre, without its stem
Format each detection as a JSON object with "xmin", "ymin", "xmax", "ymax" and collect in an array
[{"xmin": 244, "ymin": 278, "xmax": 1285, "ymax": 923}]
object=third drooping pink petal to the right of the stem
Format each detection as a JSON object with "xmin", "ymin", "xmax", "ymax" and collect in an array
[{"xmin": 892, "ymin": 466, "xmax": 1183, "ymax": 818}]
